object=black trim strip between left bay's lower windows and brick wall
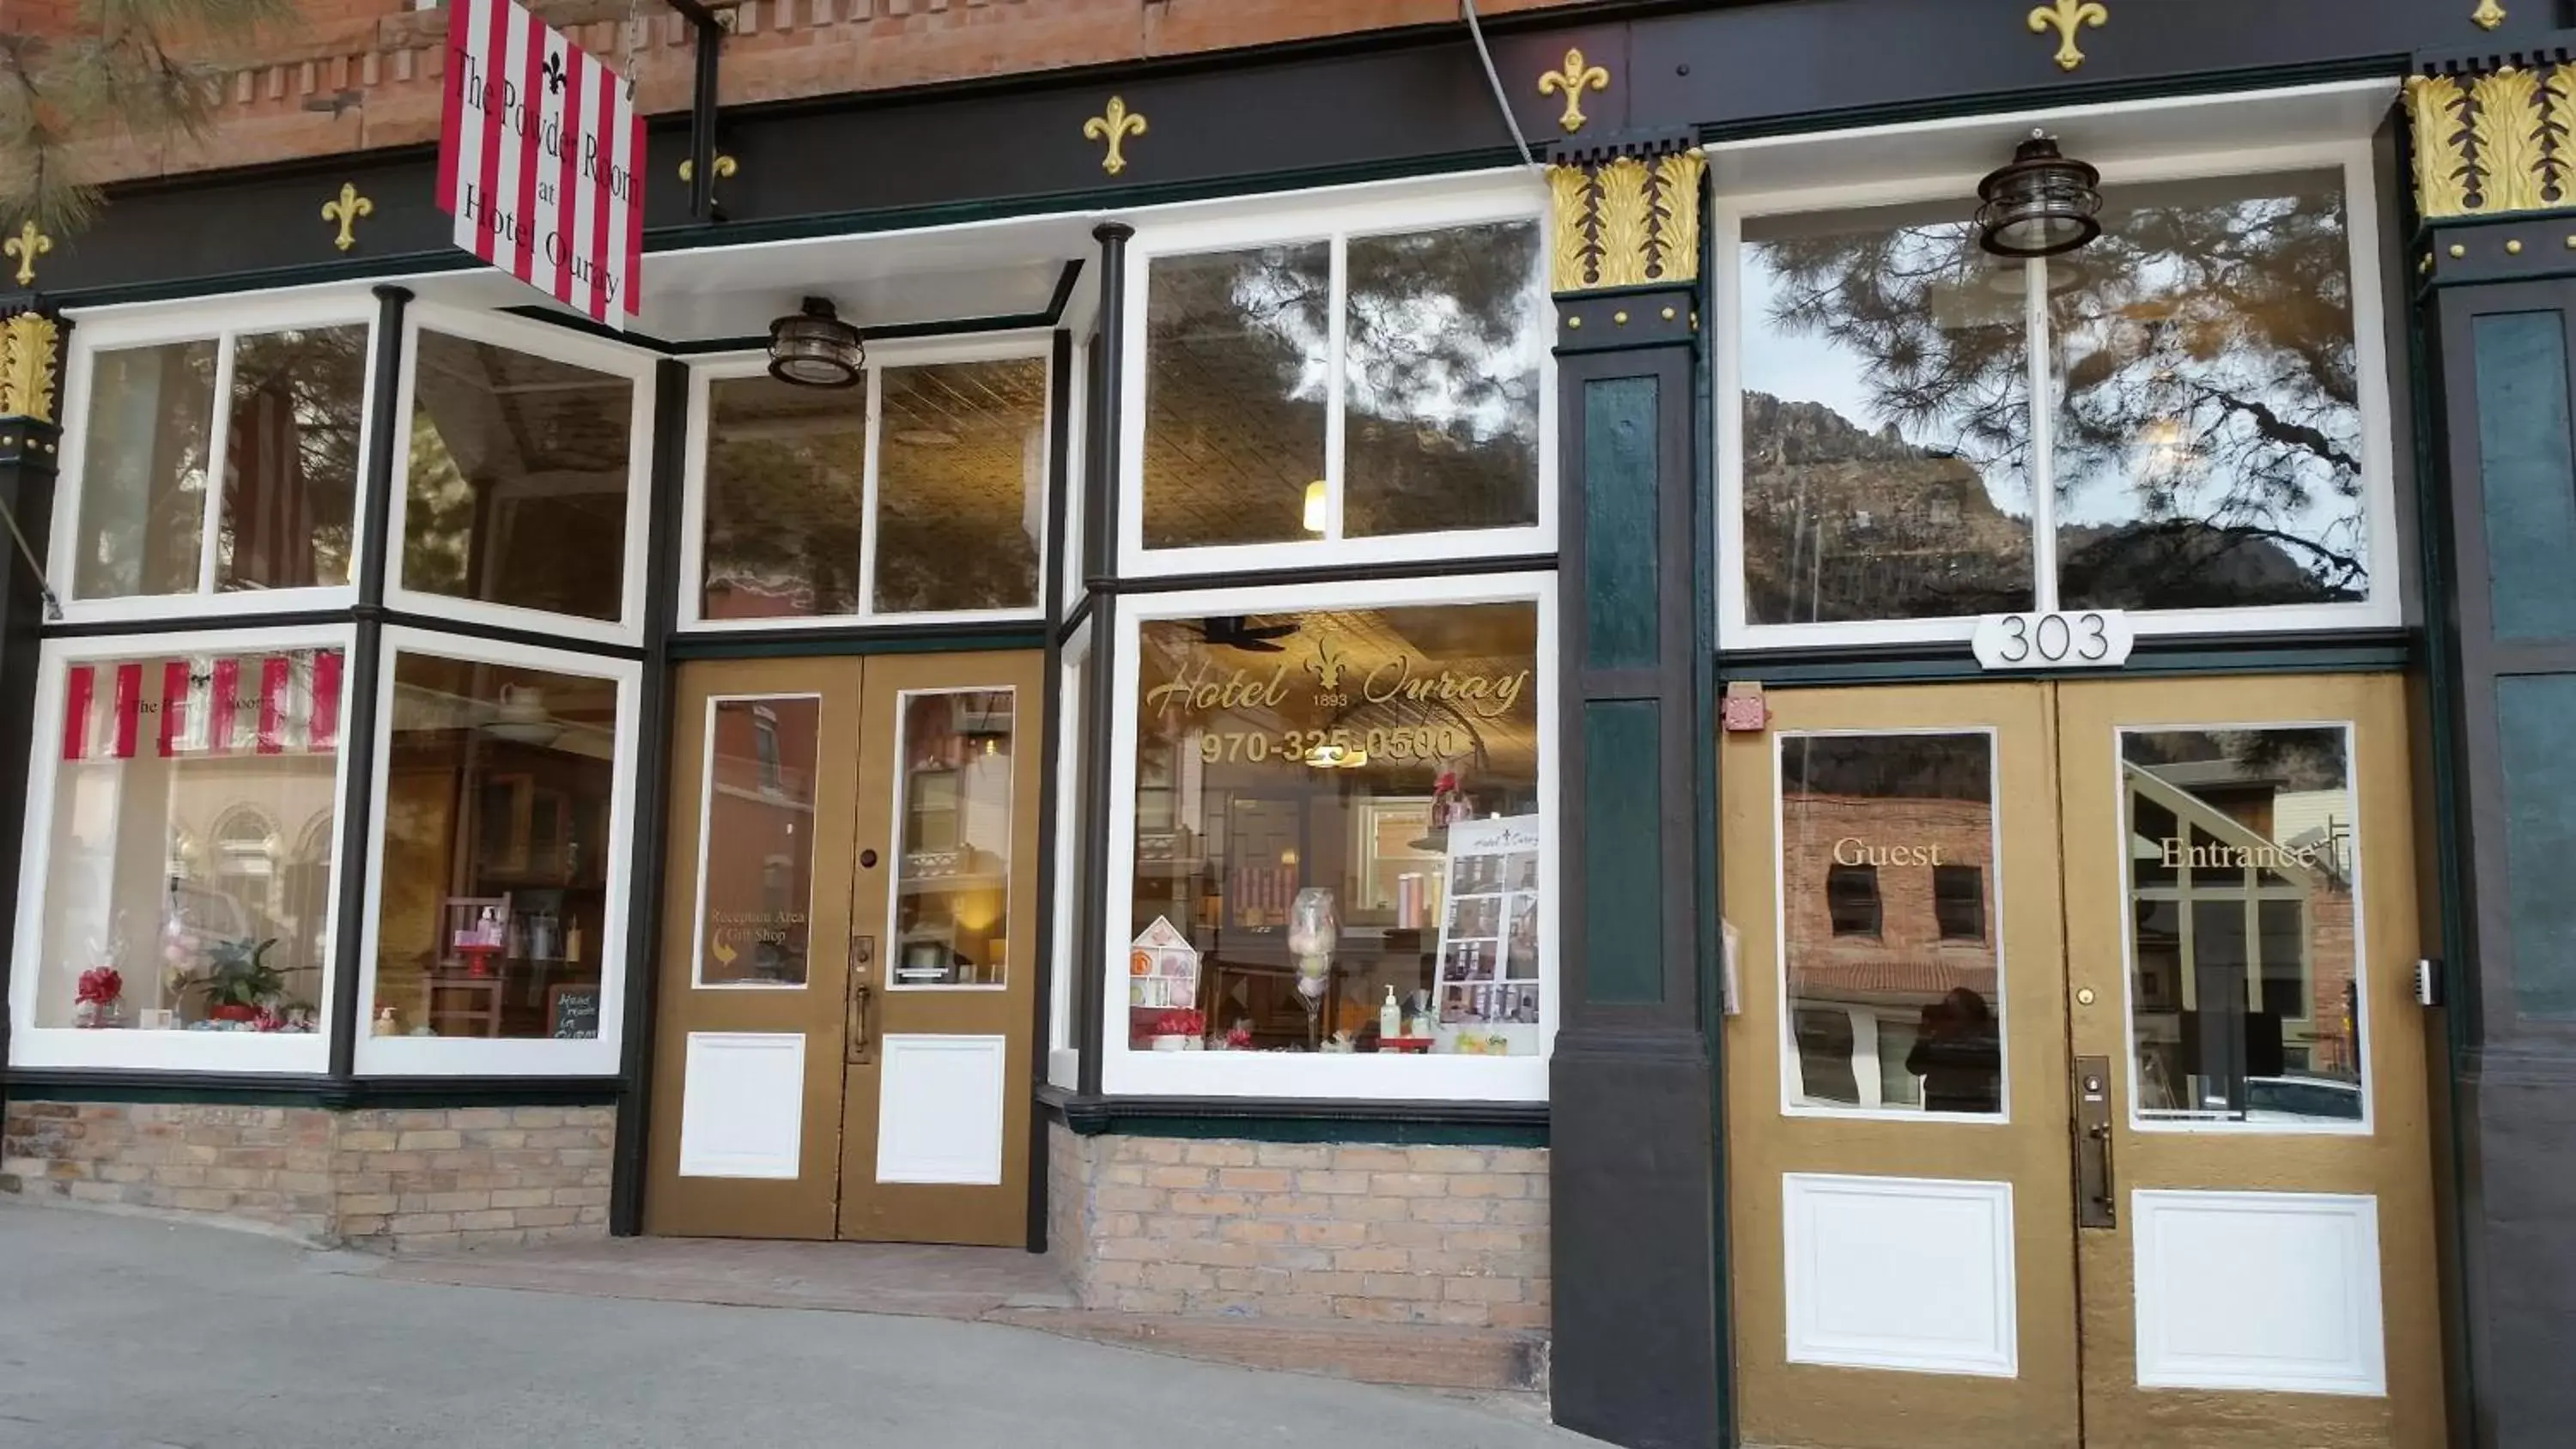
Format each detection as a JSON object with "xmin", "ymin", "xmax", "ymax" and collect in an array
[{"xmin": 5, "ymin": 1068, "xmax": 621, "ymax": 1112}]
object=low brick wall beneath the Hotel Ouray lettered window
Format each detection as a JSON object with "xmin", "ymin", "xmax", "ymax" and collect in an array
[{"xmin": 1048, "ymin": 1125, "xmax": 1548, "ymax": 1331}]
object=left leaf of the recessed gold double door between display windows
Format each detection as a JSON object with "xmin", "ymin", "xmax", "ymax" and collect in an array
[{"xmin": 644, "ymin": 659, "xmax": 866, "ymax": 1238}]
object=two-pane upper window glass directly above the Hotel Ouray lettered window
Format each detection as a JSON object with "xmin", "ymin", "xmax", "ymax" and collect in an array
[{"xmin": 1141, "ymin": 219, "xmax": 1548, "ymax": 549}]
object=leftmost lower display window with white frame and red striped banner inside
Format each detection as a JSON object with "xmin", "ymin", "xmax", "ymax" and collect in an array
[{"xmin": 10, "ymin": 628, "xmax": 348, "ymax": 1070}]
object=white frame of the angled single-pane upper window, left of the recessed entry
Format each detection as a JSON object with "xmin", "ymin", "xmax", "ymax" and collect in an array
[{"xmin": 384, "ymin": 301, "xmax": 654, "ymax": 644}]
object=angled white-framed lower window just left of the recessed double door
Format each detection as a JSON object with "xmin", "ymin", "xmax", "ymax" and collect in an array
[{"xmin": 358, "ymin": 631, "xmax": 636, "ymax": 1076}]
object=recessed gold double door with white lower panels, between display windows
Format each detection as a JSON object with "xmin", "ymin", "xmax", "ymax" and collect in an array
[{"xmin": 644, "ymin": 654, "xmax": 1043, "ymax": 1246}]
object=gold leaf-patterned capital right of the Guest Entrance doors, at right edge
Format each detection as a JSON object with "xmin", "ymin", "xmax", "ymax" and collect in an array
[{"xmin": 2406, "ymin": 64, "xmax": 2576, "ymax": 221}]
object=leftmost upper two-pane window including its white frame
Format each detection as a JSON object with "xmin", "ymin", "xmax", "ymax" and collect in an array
[{"xmin": 52, "ymin": 296, "xmax": 376, "ymax": 621}]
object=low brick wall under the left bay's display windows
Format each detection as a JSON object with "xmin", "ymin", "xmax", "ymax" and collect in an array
[{"xmin": 0, "ymin": 1101, "xmax": 616, "ymax": 1251}]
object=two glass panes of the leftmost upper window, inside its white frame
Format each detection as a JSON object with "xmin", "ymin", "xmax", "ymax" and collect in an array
[{"xmin": 72, "ymin": 324, "xmax": 368, "ymax": 600}]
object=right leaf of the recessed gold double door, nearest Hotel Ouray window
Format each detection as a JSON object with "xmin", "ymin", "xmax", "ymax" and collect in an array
[{"xmin": 840, "ymin": 654, "xmax": 1046, "ymax": 1248}]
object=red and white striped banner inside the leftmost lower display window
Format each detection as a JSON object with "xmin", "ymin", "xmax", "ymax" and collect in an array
[{"xmin": 62, "ymin": 649, "xmax": 343, "ymax": 761}]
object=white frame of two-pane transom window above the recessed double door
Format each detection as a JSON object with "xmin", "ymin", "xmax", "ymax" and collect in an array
[{"xmin": 675, "ymin": 332, "xmax": 1061, "ymax": 634}]
